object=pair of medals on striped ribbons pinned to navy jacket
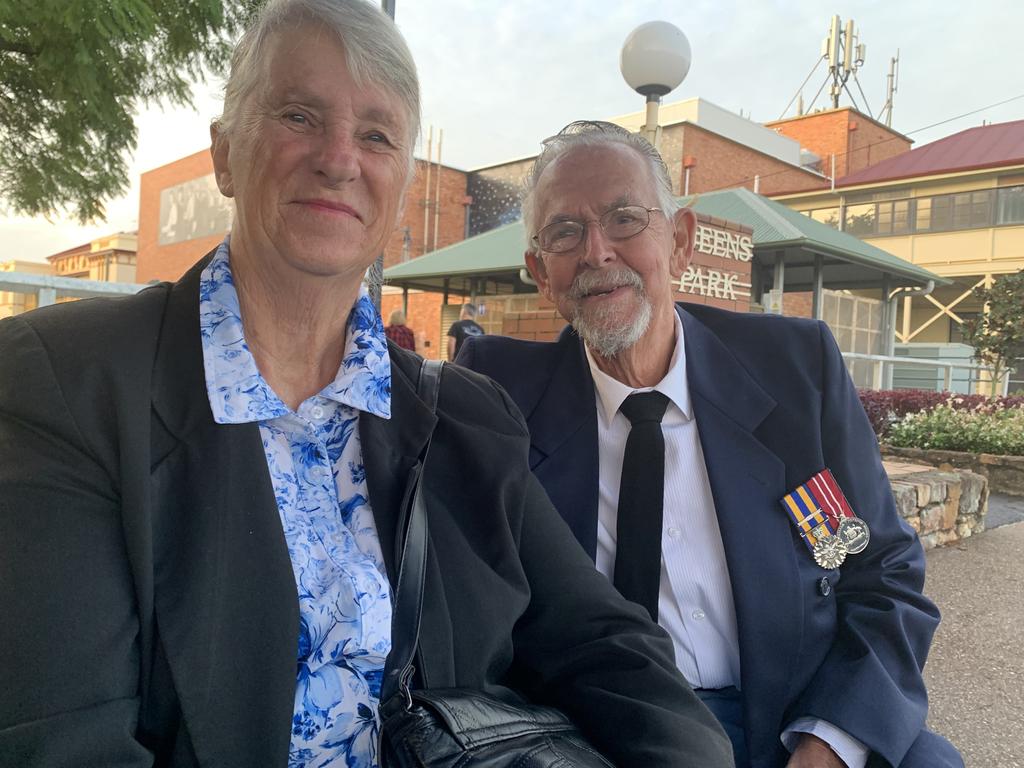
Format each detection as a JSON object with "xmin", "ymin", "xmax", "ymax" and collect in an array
[{"xmin": 781, "ymin": 469, "xmax": 871, "ymax": 569}]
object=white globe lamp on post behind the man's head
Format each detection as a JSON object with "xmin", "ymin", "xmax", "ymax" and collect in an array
[{"xmin": 618, "ymin": 22, "xmax": 692, "ymax": 147}]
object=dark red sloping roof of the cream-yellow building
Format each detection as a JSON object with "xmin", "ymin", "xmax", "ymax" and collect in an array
[{"xmin": 836, "ymin": 120, "xmax": 1024, "ymax": 186}]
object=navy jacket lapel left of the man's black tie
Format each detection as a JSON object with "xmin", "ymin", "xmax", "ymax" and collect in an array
[{"xmin": 524, "ymin": 327, "xmax": 599, "ymax": 559}]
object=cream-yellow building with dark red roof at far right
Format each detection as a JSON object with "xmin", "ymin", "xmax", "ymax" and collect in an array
[{"xmin": 773, "ymin": 120, "xmax": 1024, "ymax": 344}]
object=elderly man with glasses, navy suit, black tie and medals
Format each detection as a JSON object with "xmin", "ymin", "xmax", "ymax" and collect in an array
[{"xmin": 457, "ymin": 123, "xmax": 962, "ymax": 768}]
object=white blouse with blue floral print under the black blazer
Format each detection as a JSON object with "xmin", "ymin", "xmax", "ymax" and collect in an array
[{"xmin": 200, "ymin": 240, "xmax": 391, "ymax": 768}]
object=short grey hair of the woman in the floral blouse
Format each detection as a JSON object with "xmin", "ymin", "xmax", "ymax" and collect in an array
[{"xmin": 215, "ymin": 0, "xmax": 420, "ymax": 170}]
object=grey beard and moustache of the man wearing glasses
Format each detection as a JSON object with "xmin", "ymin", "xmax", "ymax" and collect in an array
[{"xmin": 566, "ymin": 267, "xmax": 653, "ymax": 357}]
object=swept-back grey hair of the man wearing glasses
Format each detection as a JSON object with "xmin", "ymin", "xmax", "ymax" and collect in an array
[{"xmin": 522, "ymin": 120, "xmax": 680, "ymax": 251}]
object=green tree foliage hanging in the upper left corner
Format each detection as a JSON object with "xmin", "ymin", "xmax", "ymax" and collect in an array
[{"xmin": 0, "ymin": 0, "xmax": 262, "ymax": 223}]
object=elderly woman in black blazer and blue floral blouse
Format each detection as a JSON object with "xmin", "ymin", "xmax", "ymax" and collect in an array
[{"xmin": 0, "ymin": 0, "xmax": 729, "ymax": 768}]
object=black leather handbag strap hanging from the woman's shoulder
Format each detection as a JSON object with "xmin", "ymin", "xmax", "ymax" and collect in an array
[{"xmin": 380, "ymin": 359, "xmax": 444, "ymax": 709}]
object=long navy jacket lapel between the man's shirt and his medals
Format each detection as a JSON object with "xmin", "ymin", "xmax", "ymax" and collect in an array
[{"xmin": 679, "ymin": 308, "xmax": 803, "ymax": 756}]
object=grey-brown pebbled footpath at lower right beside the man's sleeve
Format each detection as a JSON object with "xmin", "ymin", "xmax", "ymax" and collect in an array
[{"xmin": 925, "ymin": 520, "xmax": 1024, "ymax": 768}]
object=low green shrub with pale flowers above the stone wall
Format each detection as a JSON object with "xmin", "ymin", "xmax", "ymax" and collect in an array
[{"xmin": 886, "ymin": 403, "xmax": 1024, "ymax": 456}]
